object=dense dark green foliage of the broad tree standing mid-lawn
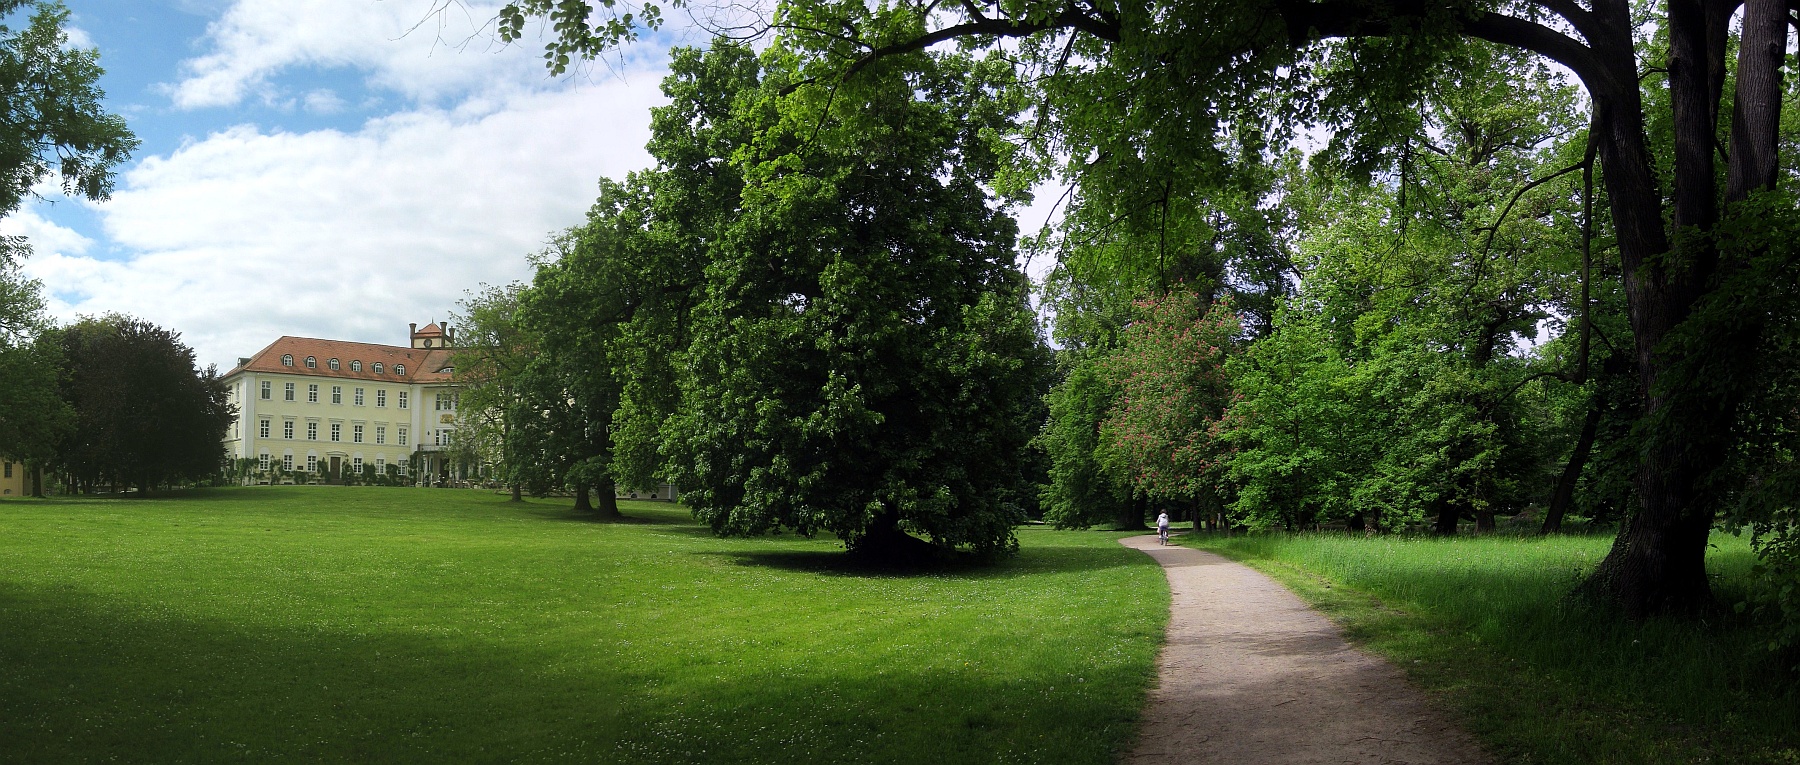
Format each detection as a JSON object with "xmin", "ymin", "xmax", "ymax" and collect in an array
[{"xmin": 664, "ymin": 47, "xmax": 1046, "ymax": 553}]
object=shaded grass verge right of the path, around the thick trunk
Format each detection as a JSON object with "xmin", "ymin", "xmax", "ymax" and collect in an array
[{"xmin": 1181, "ymin": 535, "xmax": 1800, "ymax": 765}]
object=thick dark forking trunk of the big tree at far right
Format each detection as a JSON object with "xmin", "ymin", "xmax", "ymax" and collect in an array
[{"xmin": 1582, "ymin": 0, "xmax": 1730, "ymax": 617}]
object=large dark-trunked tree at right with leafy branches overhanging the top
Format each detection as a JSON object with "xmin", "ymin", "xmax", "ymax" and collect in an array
[{"xmin": 502, "ymin": 0, "xmax": 1793, "ymax": 616}]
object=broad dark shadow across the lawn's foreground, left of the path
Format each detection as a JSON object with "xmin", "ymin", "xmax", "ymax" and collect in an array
[{"xmin": 0, "ymin": 581, "xmax": 1143, "ymax": 765}]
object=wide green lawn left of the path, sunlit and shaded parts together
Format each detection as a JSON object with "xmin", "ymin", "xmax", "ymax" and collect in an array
[{"xmin": 0, "ymin": 486, "xmax": 1168, "ymax": 765}]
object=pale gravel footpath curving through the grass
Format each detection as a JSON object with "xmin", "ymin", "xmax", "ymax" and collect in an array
[{"xmin": 1120, "ymin": 536, "xmax": 1492, "ymax": 765}]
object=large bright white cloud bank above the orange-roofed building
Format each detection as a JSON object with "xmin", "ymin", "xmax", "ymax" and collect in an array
[{"xmin": 19, "ymin": 73, "xmax": 662, "ymax": 367}]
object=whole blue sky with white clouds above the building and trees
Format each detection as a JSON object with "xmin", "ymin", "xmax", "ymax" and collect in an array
[{"xmin": 0, "ymin": 0, "xmax": 1057, "ymax": 367}]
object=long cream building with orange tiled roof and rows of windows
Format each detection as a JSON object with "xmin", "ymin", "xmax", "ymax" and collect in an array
[{"xmin": 223, "ymin": 322, "xmax": 457, "ymax": 482}]
